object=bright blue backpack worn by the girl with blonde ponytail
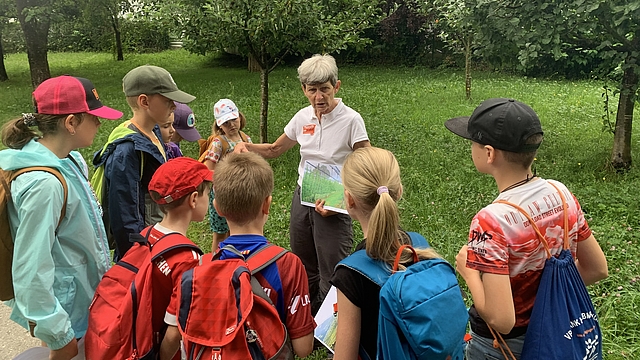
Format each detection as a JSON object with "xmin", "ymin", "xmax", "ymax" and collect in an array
[{"xmin": 338, "ymin": 232, "xmax": 468, "ymax": 360}]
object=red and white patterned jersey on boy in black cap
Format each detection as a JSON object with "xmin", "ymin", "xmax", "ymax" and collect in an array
[{"xmin": 467, "ymin": 179, "xmax": 591, "ymax": 327}]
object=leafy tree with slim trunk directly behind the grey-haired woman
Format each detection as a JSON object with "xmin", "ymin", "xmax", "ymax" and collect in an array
[{"xmin": 183, "ymin": 0, "xmax": 378, "ymax": 142}]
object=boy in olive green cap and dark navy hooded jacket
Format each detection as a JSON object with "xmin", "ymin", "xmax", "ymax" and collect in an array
[{"xmin": 91, "ymin": 65, "xmax": 195, "ymax": 260}]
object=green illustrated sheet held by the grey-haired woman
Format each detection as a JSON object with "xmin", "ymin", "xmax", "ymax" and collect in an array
[{"xmin": 300, "ymin": 161, "xmax": 347, "ymax": 214}]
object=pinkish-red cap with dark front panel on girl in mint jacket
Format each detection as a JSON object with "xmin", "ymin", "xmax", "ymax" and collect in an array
[{"xmin": 33, "ymin": 75, "xmax": 122, "ymax": 120}]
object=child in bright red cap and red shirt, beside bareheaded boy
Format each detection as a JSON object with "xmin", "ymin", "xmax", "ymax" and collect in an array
[{"xmin": 142, "ymin": 157, "xmax": 213, "ymax": 360}]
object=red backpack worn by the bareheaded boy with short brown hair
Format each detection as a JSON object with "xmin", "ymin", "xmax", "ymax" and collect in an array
[{"xmin": 178, "ymin": 244, "xmax": 293, "ymax": 360}]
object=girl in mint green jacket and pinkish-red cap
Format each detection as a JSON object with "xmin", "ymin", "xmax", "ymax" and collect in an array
[{"xmin": 0, "ymin": 75, "xmax": 122, "ymax": 360}]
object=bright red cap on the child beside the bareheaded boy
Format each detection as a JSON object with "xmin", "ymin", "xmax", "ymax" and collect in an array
[{"xmin": 149, "ymin": 156, "xmax": 213, "ymax": 204}]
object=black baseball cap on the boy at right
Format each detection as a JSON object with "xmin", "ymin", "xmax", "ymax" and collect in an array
[{"xmin": 444, "ymin": 98, "xmax": 543, "ymax": 153}]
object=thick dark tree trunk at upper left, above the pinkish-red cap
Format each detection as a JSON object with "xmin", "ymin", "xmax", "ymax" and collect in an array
[{"xmin": 16, "ymin": 0, "xmax": 51, "ymax": 88}]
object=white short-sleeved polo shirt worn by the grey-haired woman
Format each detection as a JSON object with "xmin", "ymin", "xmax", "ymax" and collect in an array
[{"xmin": 284, "ymin": 98, "xmax": 369, "ymax": 186}]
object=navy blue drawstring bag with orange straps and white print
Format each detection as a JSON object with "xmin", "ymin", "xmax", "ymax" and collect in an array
[{"xmin": 496, "ymin": 183, "xmax": 602, "ymax": 360}]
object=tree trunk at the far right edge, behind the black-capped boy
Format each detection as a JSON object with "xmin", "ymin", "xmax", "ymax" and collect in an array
[{"xmin": 611, "ymin": 58, "xmax": 638, "ymax": 170}]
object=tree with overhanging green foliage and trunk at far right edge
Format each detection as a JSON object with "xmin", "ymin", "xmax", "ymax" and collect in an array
[{"xmin": 474, "ymin": 0, "xmax": 640, "ymax": 169}]
